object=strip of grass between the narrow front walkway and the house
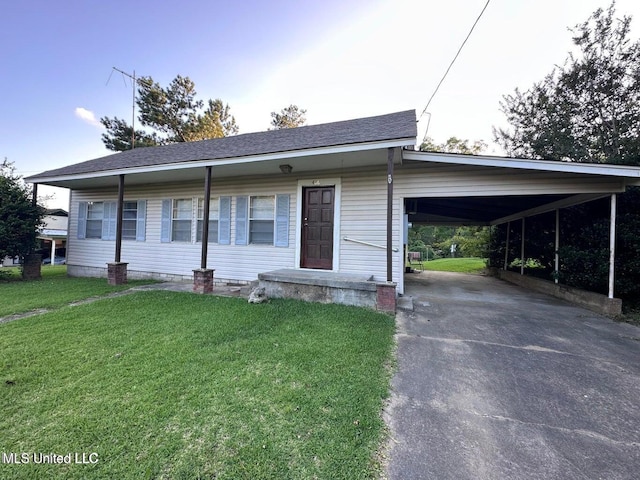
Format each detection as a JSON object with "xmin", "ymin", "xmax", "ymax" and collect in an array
[{"xmin": 0, "ymin": 265, "xmax": 151, "ymax": 317}]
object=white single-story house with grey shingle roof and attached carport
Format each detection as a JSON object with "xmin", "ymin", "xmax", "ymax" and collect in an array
[{"xmin": 26, "ymin": 110, "xmax": 640, "ymax": 312}]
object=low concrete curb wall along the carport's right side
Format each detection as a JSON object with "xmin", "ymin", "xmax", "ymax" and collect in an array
[{"xmin": 495, "ymin": 270, "xmax": 622, "ymax": 317}]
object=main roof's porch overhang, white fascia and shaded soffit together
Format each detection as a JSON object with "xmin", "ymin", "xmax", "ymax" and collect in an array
[{"xmin": 25, "ymin": 137, "xmax": 415, "ymax": 189}]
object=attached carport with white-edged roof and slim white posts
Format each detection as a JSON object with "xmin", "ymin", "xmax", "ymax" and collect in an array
[{"xmin": 394, "ymin": 150, "xmax": 640, "ymax": 308}]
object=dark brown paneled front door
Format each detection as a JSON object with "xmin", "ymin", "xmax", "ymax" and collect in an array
[{"xmin": 300, "ymin": 187, "xmax": 335, "ymax": 270}]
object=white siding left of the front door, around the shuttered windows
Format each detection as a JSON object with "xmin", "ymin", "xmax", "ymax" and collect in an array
[{"xmin": 67, "ymin": 178, "xmax": 297, "ymax": 281}]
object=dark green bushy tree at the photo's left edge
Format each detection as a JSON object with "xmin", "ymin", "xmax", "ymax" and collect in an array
[{"xmin": 0, "ymin": 158, "xmax": 44, "ymax": 261}]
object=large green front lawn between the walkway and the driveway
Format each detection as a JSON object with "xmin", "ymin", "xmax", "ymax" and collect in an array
[{"xmin": 0, "ymin": 285, "xmax": 394, "ymax": 479}]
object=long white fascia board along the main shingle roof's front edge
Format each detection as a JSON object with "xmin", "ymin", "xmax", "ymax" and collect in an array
[{"xmin": 25, "ymin": 137, "xmax": 416, "ymax": 184}]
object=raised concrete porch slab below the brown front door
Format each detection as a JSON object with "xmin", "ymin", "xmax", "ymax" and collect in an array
[{"xmin": 258, "ymin": 269, "xmax": 396, "ymax": 313}]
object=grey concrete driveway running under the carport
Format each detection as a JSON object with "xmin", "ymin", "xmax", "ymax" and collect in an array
[{"xmin": 386, "ymin": 272, "xmax": 640, "ymax": 480}]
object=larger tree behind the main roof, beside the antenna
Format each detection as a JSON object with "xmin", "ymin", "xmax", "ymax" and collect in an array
[{"xmin": 100, "ymin": 75, "xmax": 238, "ymax": 151}]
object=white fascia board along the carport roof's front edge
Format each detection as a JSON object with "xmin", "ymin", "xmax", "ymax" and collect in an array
[{"xmin": 402, "ymin": 150, "xmax": 640, "ymax": 179}]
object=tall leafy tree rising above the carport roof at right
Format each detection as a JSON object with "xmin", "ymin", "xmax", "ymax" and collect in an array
[{"xmin": 494, "ymin": 2, "xmax": 640, "ymax": 165}]
